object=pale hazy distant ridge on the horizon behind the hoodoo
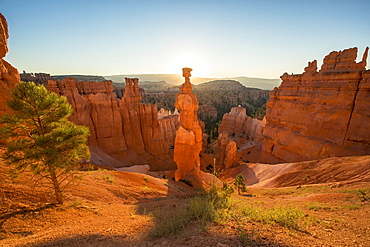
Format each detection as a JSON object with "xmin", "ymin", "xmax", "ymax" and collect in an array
[{"xmin": 104, "ymin": 74, "xmax": 281, "ymax": 90}]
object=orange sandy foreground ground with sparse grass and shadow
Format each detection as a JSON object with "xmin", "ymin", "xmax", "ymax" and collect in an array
[{"xmin": 0, "ymin": 151, "xmax": 370, "ymax": 247}]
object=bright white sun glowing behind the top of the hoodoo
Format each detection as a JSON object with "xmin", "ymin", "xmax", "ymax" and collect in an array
[{"xmin": 168, "ymin": 53, "xmax": 207, "ymax": 77}]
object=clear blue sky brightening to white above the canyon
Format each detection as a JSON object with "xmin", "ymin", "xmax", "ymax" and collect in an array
[{"xmin": 0, "ymin": 0, "xmax": 370, "ymax": 78}]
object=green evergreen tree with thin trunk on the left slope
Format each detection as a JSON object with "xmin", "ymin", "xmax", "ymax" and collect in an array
[{"xmin": 0, "ymin": 82, "xmax": 90, "ymax": 204}]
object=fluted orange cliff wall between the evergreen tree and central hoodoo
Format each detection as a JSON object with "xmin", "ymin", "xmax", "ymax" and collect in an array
[{"xmin": 47, "ymin": 78, "xmax": 175, "ymax": 170}]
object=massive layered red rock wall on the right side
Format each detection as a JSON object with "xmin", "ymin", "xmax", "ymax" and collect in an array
[{"xmin": 262, "ymin": 48, "xmax": 370, "ymax": 163}]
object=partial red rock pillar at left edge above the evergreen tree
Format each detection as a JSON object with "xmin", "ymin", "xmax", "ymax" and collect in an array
[{"xmin": 0, "ymin": 13, "xmax": 19, "ymax": 142}]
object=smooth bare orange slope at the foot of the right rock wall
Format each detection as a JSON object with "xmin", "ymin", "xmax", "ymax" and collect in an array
[{"xmin": 223, "ymin": 155, "xmax": 370, "ymax": 188}]
